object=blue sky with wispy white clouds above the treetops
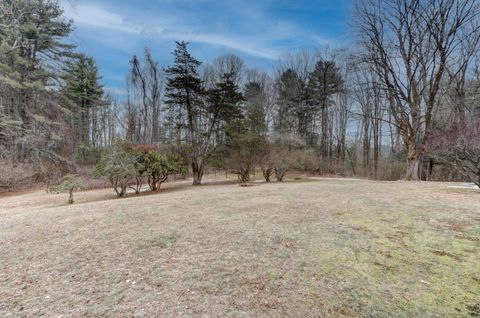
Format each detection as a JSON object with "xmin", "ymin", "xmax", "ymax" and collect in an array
[{"xmin": 61, "ymin": 0, "xmax": 353, "ymax": 92}]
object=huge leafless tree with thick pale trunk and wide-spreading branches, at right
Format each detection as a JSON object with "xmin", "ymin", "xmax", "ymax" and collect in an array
[{"xmin": 356, "ymin": 0, "xmax": 480, "ymax": 180}]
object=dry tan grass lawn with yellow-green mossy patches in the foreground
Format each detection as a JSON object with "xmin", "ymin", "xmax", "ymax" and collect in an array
[{"xmin": 0, "ymin": 179, "xmax": 480, "ymax": 317}]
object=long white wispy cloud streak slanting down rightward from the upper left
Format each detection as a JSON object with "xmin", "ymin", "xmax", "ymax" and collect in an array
[{"xmin": 64, "ymin": 2, "xmax": 338, "ymax": 60}]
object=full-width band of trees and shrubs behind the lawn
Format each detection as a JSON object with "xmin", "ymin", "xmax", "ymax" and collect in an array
[{"xmin": 0, "ymin": 0, "xmax": 480, "ymax": 191}]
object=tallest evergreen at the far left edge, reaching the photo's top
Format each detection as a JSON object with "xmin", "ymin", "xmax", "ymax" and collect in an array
[{"xmin": 0, "ymin": 0, "xmax": 73, "ymax": 160}]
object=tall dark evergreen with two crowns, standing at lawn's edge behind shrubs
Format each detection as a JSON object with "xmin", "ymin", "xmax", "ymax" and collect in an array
[{"xmin": 165, "ymin": 42, "xmax": 243, "ymax": 185}]
